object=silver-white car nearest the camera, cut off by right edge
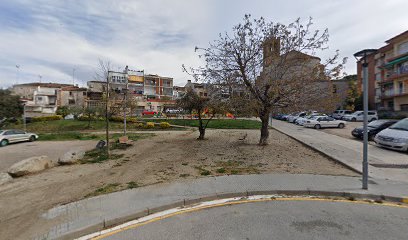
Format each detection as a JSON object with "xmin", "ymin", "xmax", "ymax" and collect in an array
[{"xmin": 374, "ymin": 118, "xmax": 408, "ymax": 152}]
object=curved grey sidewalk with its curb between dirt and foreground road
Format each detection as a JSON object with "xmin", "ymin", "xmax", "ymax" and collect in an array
[{"xmin": 32, "ymin": 174, "xmax": 408, "ymax": 239}]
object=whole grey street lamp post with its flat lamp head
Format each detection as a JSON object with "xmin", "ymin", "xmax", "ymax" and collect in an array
[{"xmin": 354, "ymin": 49, "xmax": 377, "ymax": 190}]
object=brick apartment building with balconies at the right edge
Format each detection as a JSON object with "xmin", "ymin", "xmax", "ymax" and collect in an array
[{"xmin": 357, "ymin": 31, "xmax": 408, "ymax": 111}]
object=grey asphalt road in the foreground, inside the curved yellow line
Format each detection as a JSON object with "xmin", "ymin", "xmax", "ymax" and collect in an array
[{"xmin": 102, "ymin": 201, "xmax": 408, "ymax": 240}]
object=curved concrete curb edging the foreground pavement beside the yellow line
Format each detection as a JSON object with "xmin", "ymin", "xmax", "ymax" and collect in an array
[{"xmin": 57, "ymin": 190, "xmax": 408, "ymax": 240}]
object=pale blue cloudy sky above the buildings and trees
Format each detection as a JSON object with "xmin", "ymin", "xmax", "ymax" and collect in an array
[{"xmin": 0, "ymin": 0, "xmax": 408, "ymax": 88}]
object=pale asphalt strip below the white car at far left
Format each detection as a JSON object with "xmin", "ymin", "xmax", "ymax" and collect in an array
[{"xmin": 0, "ymin": 141, "xmax": 97, "ymax": 172}]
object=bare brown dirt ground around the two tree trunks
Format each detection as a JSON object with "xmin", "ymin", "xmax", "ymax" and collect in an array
[{"xmin": 0, "ymin": 130, "xmax": 356, "ymax": 239}]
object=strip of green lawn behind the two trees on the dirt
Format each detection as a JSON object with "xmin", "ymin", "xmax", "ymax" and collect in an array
[{"xmin": 148, "ymin": 119, "xmax": 261, "ymax": 129}]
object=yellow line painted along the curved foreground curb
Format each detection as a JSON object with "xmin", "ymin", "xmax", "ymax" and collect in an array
[{"xmin": 92, "ymin": 197, "xmax": 408, "ymax": 240}]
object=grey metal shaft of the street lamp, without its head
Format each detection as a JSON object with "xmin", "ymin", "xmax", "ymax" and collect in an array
[{"xmin": 363, "ymin": 62, "xmax": 368, "ymax": 189}]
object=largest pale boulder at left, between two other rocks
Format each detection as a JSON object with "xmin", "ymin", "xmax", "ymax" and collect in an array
[{"xmin": 7, "ymin": 156, "xmax": 52, "ymax": 177}]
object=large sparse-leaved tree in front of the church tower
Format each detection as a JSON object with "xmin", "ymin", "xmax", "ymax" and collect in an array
[{"xmin": 190, "ymin": 15, "xmax": 345, "ymax": 145}]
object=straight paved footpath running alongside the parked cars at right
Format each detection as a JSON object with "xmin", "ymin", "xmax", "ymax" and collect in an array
[{"xmin": 272, "ymin": 120, "xmax": 408, "ymax": 182}]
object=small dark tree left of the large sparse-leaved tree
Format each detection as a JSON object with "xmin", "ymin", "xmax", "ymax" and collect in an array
[{"xmin": 177, "ymin": 89, "xmax": 227, "ymax": 140}]
